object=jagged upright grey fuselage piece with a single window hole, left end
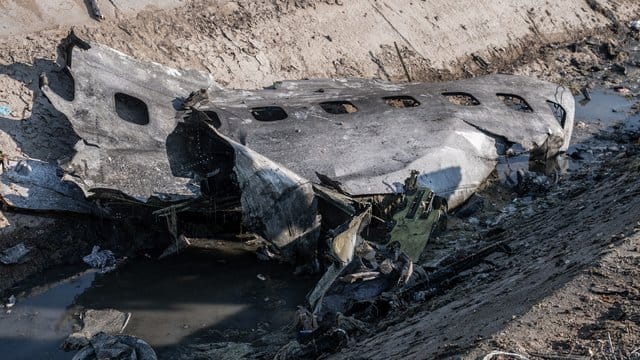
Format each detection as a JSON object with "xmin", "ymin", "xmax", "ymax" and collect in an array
[{"xmin": 42, "ymin": 39, "xmax": 217, "ymax": 202}]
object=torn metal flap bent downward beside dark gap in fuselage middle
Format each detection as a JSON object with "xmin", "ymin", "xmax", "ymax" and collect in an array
[{"xmin": 154, "ymin": 110, "xmax": 320, "ymax": 259}]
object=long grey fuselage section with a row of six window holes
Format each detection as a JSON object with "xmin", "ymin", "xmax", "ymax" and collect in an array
[{"xmin": 198, "ymin": 75, "xmax": 574, "ymax": 207}]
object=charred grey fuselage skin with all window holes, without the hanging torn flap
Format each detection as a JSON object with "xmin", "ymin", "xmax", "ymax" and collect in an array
[{"xmin": 44, "ymin": 40, "xmax": 574, "ymax": 207}]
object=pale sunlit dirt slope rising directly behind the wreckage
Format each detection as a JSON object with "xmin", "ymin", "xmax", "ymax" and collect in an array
[{"xmin": 11, "ymin": 0, "xmax": 640, "ymax": 87}]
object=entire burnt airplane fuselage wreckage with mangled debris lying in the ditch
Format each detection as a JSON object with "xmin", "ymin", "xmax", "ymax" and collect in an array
[{"xmin": 0, "ymin": 36, "xmax": 574, "ymax": 324}]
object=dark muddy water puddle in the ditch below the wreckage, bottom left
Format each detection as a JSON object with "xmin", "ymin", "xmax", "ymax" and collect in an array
[{"xmin": 0, "ymin": 243, "xmax": 317, "ymax": 359}]
